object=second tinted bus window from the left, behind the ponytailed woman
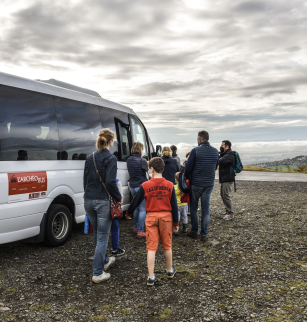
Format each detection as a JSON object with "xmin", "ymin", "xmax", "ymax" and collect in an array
[{"xmin": 55, "ymin": 97, "xmax": 101, "ymax": 160}]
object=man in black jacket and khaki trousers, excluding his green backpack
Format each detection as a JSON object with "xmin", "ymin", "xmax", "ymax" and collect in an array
[{"xmin": 219, "ymin": 140, "xmax": 236, "ymax": 220}]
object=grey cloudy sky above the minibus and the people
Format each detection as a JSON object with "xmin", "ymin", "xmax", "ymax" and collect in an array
[{"xmin": 0, "ymin": 0, "xmax": 307, "ymax": 164}]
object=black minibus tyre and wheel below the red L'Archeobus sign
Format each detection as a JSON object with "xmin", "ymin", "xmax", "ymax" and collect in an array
[{"xmin": 45, "ymin": 204, "xmax": 72, "ymax": 247}]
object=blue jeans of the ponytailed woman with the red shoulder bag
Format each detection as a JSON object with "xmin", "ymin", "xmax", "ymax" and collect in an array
[{"xmin": 84, "ymin": 199, "xmax": 112, "ymax": 276}]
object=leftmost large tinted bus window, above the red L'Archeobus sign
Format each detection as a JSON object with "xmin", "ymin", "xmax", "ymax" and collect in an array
[{"xmin": 0, "ymin": 85, "xmax": 59, "ymax": 161}]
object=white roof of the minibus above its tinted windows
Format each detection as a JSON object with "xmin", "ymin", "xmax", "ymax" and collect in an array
[{"xmin": 0, "ymin": 72, "xmax": 135, "ymax": 114}]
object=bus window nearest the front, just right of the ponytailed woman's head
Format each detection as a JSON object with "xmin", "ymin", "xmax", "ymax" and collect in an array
[{"xmin": 99, "ymin": 106, "xmax": 131, "ymax": 161}]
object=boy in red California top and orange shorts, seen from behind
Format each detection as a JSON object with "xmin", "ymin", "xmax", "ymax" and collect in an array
[{"xmin": 127, "ymin": 157, "xmax": 179, "ymax": 286}]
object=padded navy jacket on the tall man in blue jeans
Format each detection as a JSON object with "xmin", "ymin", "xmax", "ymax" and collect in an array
[{"xmin": 185, "ymin": 142, "xmax": 219, "ymax": 187}]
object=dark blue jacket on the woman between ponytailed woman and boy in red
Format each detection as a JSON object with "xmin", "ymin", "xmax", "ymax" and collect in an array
[{"xmin": 127, "ymin": 154, "xmax": 148, "ymax": 188}]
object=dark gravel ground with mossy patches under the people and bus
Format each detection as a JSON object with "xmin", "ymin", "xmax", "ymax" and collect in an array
[{"xmin": 0, "ymin": 181, "xmax": 307, "ymax": 322}]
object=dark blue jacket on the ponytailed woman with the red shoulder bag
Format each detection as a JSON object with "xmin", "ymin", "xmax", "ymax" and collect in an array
[{"xmin": 83, "ymin": 149, "xmax": 122, "ymax": 200}]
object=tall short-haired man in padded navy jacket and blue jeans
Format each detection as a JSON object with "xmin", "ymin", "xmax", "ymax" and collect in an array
[{"xmin": 185, "ymin": 131, "xmax": 219, "ymax": 241}]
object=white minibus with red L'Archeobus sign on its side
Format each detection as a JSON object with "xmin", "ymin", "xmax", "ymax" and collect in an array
[{"xmin": 0, "ymin": 72, "xmax": 160, "ymax": 246}]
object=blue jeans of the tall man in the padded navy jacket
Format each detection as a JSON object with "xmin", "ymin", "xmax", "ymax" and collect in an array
[{"xmin": 190, "ymin": 185, "xmax": 213, "ymax": 236}]
